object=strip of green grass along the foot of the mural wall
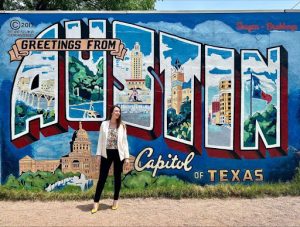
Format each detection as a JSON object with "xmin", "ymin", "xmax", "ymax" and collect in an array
[{"xmin": 0, "ymin": 168, "xmax": 300, "ymax": 201}]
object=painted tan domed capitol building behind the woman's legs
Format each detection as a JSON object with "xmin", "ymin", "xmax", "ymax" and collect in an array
[{"xmin": 19, "ymin": 122, "xmax": 135, "ymax": 179}]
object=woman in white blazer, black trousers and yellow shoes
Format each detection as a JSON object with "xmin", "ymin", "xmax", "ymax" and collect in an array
[{"xmin": 91, "ymin": 106, "xmax": 129, "ymax": 214}]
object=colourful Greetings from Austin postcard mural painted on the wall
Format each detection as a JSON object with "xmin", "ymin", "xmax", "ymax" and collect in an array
[{"xmin": 0, "ymin": 12, "xmax": 300, "ymax": 192}]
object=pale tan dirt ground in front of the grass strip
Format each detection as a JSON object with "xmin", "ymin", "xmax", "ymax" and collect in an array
[{"xmin": 0, "ymin": 197, "xmax": 300, "ymax": 226}]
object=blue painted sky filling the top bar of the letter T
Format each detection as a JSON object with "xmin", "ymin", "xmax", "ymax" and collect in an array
[{"xmin": 162, "ymin": 35, "xmax": 199, "ymax": 66}]
